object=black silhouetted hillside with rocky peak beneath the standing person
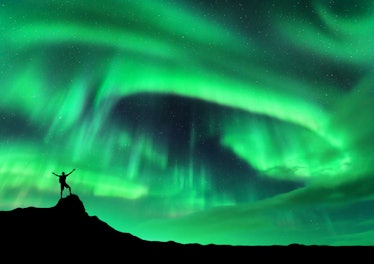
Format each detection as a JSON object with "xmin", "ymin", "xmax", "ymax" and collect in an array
[{"xmin": 0, "ymin": 194, "xmax": 372, "ymax": 263}]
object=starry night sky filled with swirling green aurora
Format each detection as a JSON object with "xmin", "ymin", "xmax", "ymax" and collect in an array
[{"xmin": 0, "ymin": 0, "xmax": 374, "ymax": 246}]
